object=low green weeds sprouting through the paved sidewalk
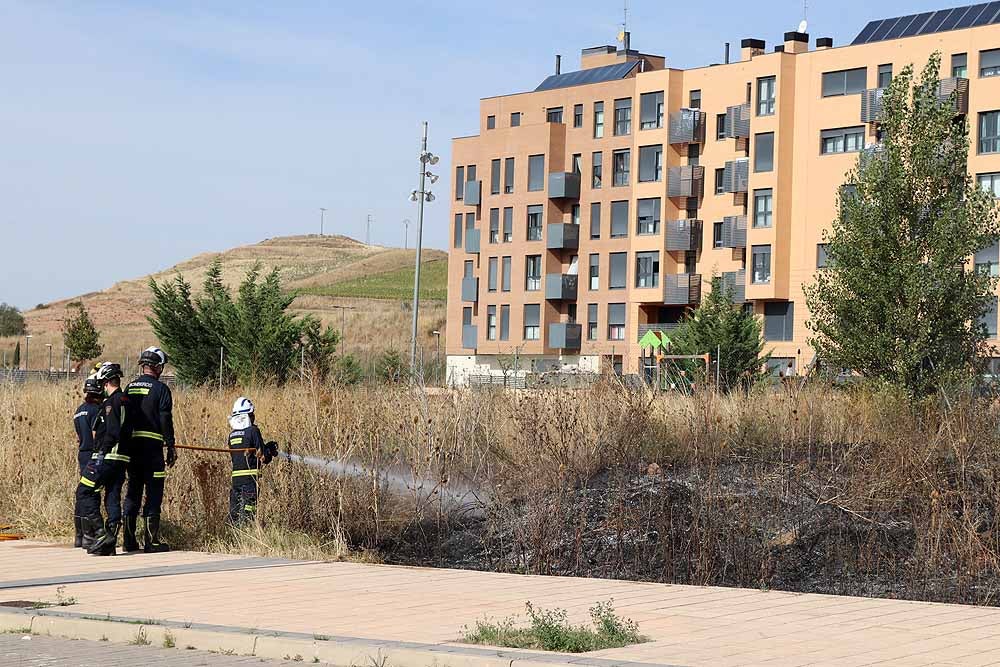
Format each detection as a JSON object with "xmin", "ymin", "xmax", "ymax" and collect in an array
[{"xmin": 462, "ymin": 600, "xmax": 649, "ymax": 653}]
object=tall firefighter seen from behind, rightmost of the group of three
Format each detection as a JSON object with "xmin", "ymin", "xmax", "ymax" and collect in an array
[{"xmin": 122, "ymin": 347, "xmax": 177, "ymax": 553}]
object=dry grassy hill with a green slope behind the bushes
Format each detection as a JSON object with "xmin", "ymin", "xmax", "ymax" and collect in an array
[{"xmin": 0, "ymin": 235, "xmax": 447, "ymax": 369}]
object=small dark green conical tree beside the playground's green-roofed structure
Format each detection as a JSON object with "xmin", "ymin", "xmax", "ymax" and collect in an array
[{"xmin": 670, "ymin": 275, "xmax": 770, "ymax": 391}]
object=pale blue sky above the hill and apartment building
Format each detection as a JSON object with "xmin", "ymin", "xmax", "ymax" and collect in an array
[{"xmin": 0, "ymin": 0, "xmax": 962, "ymax": 308}]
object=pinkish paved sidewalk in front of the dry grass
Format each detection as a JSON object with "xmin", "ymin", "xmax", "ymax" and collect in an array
[{"xmin": 0, "ymin": 543, "xmax": 1000, "ymax": 667}]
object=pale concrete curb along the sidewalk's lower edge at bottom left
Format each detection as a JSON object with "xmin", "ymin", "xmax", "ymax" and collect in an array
[{"xmin": 0, "ymin": 608, "xmax": 677, "ymax": 667}]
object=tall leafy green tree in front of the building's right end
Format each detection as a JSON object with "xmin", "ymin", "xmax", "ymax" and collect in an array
[{"xmin": 806, "ymin": 54, "xmax": 1000, "ymax": 395}]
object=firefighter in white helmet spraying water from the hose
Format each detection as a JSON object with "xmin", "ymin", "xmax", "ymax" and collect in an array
[{"xmin": 229, "ymin": 396, "xmax": 278, "ymax": 526}]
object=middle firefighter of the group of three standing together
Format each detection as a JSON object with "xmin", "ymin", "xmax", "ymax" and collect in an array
[{"xmin": 76, "ymin": 363, "xmax": 132, "ymax": 556}]
